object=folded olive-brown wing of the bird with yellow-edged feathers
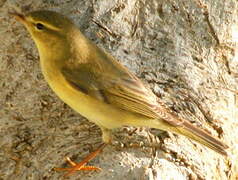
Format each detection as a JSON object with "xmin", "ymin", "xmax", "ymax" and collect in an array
[{"xmin": 62, "ymin": 57, "xmax": 183, "ymax": 126}]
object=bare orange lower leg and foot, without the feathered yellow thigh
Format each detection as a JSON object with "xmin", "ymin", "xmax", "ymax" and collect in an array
[{"xmin": 54, "ymin": 143, "xmax": 106, "ymax": 176}]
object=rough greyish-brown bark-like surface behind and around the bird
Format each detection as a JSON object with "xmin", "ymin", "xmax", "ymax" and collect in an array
[{"xmin": 0, "ymin": 0, "xmax": 238, "ymax": 180}]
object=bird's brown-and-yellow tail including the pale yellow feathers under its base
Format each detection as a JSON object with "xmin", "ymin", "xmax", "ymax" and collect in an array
[{"xmin": 124, "ymin": 113, "xmax": 229, "ymax": 155}]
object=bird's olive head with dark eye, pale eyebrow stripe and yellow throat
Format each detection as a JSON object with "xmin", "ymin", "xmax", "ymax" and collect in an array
[{"xmin": 12, "ymin": 10, "xmax": 75, "ymax": 60}]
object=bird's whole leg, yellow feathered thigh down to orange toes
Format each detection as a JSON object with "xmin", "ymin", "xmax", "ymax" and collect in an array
[{"xmin": 54, "ymin": 128, "xmax": 111, "ymax": 176}]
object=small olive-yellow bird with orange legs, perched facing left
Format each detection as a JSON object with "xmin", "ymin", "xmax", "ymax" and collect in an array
[{"xmin": 11, "ymin": 10, "xmax": 229, "ymax": 175}]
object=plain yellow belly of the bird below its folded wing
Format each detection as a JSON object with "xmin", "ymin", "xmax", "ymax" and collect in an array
[{"xmin": 43, "ymin": 68, "xmax": 138, "ymax": 129}]
